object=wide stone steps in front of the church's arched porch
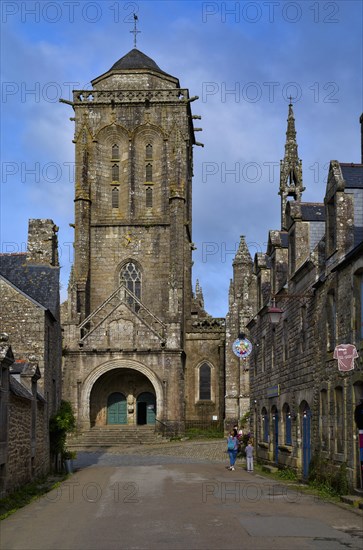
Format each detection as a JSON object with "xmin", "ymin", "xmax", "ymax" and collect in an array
[{"xmin": 67, "ymin": 425, "xmax": 169, "ymax": 451}]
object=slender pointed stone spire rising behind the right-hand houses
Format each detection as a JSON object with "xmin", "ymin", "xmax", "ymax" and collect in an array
[{"xmin": 279, "ymin": 101, "xmax": 305, "ymax": 229}]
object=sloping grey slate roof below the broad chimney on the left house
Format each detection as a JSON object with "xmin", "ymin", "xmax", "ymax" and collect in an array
[{"xmin": 0, "ymin": 253, "xmax": 59, "ymax": 319}]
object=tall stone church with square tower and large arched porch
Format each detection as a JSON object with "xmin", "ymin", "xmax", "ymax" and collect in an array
[{"xmin": 62, "ymin": 48, "xmax": 225, "ymax": 431}]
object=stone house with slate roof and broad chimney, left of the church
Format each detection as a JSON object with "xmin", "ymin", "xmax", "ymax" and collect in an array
[{"xmin": 0, "ymin": 220, "xmax": 61, "ymax": 494}]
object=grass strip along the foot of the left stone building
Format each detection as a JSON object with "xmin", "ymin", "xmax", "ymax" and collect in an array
[{"xmin": 0, "ymin": 475, "xmax": 66, "ymax": 520}]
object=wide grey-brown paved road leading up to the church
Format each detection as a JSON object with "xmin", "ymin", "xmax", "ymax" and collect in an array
[{"xmin": 0, "ymin": 442, "xmax": 363, "ymax": 550}]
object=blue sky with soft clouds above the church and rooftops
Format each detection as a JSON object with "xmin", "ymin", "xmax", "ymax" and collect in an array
[{"xmin": 0, "ymin": 0, "xmax": 363, "ymax": 316}]
